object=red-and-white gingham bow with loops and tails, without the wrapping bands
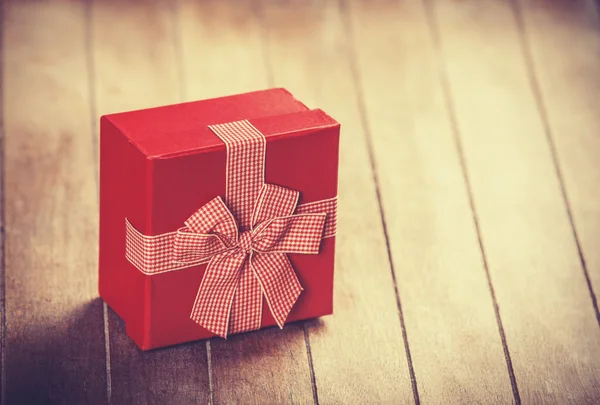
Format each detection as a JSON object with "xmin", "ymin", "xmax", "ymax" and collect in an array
[{"xmin": 172, "ymin": 184, "xmax": 327, "ymax": 337}]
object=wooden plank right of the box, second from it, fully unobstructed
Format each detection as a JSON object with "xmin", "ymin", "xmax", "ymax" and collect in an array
[{"xmin": 349, "ymin": 1, "xmax": 513, "ymax": 404}]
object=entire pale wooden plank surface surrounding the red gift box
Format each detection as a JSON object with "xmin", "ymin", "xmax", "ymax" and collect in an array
[{"xmin": 0, "ymin": 0, "xmax": 600, "ymax": 404}]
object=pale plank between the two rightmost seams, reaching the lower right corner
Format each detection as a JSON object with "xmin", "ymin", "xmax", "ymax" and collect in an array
[{"xmin": 432, "ymin": 0, "xmax": 600, "ymax": 404}]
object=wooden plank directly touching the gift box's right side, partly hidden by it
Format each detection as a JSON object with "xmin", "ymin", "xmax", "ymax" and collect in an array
[{"xmin": 262, "ymin": 1, "xmax": 413, "ymax": 404}]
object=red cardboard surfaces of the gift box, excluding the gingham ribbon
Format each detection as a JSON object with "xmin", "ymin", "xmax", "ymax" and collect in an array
[{"xmin": 99, "ymin": 89, "xmax": 340, "ymax": 350}]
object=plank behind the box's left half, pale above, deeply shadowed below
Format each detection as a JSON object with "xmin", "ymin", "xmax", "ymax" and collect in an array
[{"xmin": 90, "ymin": 0, "xmax": 209, "ymax": 404}]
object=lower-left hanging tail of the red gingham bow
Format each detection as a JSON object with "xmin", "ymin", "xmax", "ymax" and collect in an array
[{"xmin": 190, "ymin": 249, "xmax": 247, "ymax": 338}]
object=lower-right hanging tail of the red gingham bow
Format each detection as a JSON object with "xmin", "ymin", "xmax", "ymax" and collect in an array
[{"xmin": 251, "ymin": 253, "xmax": 303, "ymax": 328}]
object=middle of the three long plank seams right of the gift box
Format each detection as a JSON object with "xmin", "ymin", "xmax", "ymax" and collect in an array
[{"xmin": 423, "ymin": 0, "xmax": 521, "ymax": 405}]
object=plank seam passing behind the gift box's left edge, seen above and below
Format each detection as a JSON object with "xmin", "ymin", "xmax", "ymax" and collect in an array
[{"xmin": 83, "ymin": 0, "xmax": 112, "ymax": 404}]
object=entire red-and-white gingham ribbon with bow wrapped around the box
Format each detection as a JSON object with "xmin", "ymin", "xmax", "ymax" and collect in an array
[{"xmin": 126, "ymin": 121, "xmax": 337, "ymax": 337}]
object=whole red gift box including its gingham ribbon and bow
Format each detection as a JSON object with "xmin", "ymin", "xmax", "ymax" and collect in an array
[{"xmin": 99, "ymin": 89, "xmax": 340, "ymax": 350}]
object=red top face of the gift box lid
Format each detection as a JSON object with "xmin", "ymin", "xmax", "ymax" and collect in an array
[{"xmin": 101, "ymin": 88, "xmax": 339, "ymax": 158}]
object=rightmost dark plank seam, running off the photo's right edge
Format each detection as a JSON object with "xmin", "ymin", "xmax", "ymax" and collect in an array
[{"xmin": 511, "ymin": 0, "xmax": 600, "ymax": 326}]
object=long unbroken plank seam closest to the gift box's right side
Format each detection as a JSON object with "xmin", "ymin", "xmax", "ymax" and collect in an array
[{"xmin": 339, "ymin": 0, "xmax": 421, "ymax": 405}]
